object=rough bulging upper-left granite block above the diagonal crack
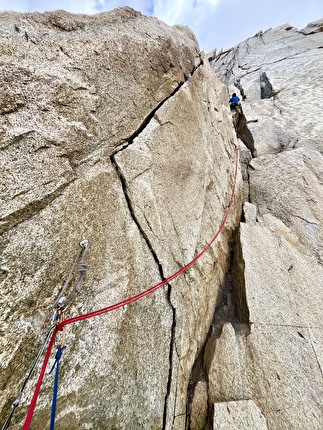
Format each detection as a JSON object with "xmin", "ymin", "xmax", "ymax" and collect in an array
[{"xmin": 0, "ymin": 9, "xmax": 198, "ymax": 235}]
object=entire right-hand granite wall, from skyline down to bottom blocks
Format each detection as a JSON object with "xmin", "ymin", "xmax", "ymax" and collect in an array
[{"xmin": 206, "ymin": 20, "xmax": 323, "ymax": 430}]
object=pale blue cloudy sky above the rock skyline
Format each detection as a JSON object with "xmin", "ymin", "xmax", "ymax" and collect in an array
[{"xmin": 0, "ymin": 0, "xmax": 323, "ymax": 52}]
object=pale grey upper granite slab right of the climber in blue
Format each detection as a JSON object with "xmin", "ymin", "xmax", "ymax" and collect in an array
[{"xmin": 212, "ymin": 20, "xmax": 323, "ymax": 156}]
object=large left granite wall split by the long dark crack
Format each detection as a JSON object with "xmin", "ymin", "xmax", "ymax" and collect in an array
[{"xmin": 0, "ymin": 8, "xmax": 242, "ymax": 429}]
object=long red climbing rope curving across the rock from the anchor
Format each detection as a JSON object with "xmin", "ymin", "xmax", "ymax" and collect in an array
[{"xmin": 22, "ymin": 147, "xmax": 239, "ymax": 430}]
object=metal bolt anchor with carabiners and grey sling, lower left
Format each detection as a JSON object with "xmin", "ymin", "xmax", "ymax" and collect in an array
[{"xmin": 1, "ymin": 240, "xmax": 89, "ymax": 430}]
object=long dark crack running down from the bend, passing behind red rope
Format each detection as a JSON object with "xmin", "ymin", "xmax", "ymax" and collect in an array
[{"xmin": 110, "ymin": 155, "xmax": 176, "ymax": 430}]
